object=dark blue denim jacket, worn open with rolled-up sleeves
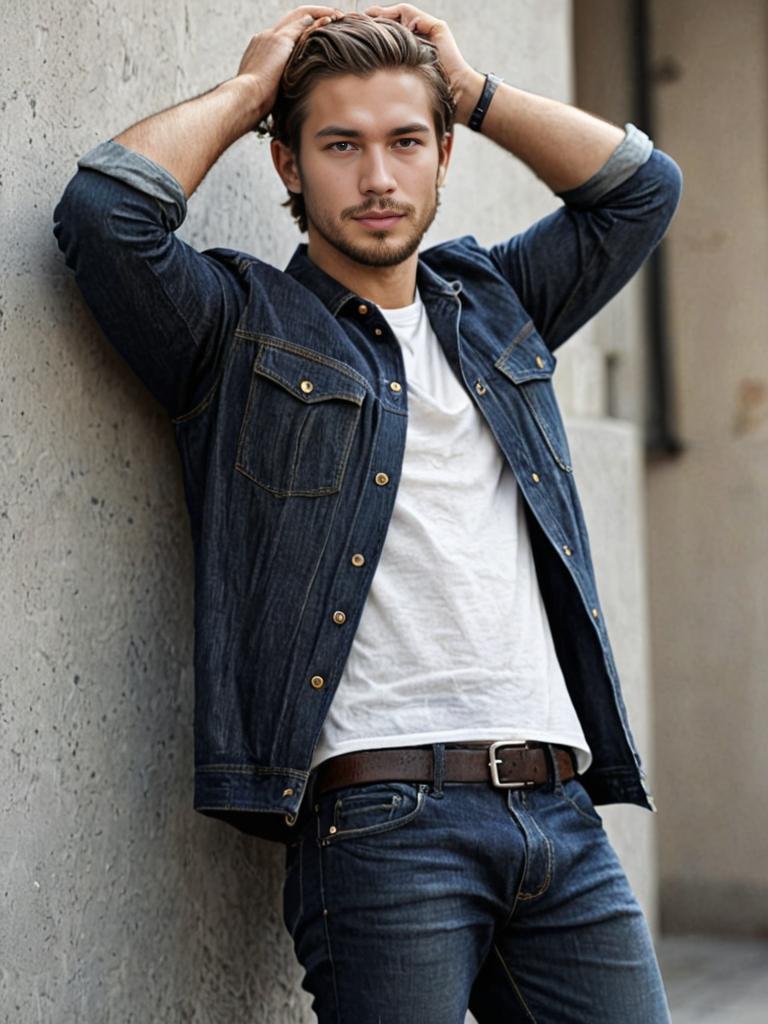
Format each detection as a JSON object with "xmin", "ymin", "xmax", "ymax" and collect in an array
[{"xmin": 55, "ymin": 126, "xmax": 680, "ymax": 841}]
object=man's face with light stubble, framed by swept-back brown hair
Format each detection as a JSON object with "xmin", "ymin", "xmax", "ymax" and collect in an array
[{"xmin": 280, "ymin": 70, "xmax": 451, "ymax": 266}]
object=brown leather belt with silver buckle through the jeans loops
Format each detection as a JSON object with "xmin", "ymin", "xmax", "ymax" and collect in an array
[{"xmin": 314, "ymin": 740, "xmax": 575, "ymax": 796}]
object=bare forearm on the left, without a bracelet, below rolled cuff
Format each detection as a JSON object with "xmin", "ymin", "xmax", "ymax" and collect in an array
[{"xmin": 115, "ymin": 76, "xmax": 262, "ymax": 197}]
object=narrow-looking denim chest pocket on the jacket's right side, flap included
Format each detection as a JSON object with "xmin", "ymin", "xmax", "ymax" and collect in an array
[{"xmin": 494, "ymin": 321, "xmax": 572, "ymax": 473}]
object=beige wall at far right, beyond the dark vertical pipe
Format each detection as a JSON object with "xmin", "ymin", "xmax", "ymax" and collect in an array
[{"xmin": 648, "ymin": 0, "xmax": 768, "ymax": 935}]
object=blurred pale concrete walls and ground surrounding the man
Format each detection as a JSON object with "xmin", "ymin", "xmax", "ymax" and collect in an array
[{"xmin": 0, "ymin": 0, "xmax": 768, "ymax": 1024}]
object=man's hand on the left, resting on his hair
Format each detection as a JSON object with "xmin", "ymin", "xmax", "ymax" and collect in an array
[{"xmin": 238, "ymin": 5, "xmax": 344, "ymax": 120}]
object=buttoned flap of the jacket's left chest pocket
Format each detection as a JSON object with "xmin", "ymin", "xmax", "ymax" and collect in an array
[{"xmin": 253, "ymin": 345, "xmax": 366, "ymax": 406}]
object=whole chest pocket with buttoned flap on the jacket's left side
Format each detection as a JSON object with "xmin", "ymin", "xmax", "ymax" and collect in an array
[{"xmin": 236, "ymin": 345, "xmax": 366, "ymax": 498}]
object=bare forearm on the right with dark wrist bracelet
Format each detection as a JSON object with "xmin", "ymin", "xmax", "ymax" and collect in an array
[{"xmin": 457, "ymin": 72, "xmax": 625, "ymax": 193}]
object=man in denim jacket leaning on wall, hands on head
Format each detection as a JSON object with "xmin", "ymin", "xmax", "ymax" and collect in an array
[{"xmin": 56, "ymin": 4, "xmax": 679, "ymax": 1024}]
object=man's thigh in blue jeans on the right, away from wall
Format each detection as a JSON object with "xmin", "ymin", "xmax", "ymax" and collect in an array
[{"xmin": 470, "ymin": 780, "xmax": 670, "ymax": 1024}]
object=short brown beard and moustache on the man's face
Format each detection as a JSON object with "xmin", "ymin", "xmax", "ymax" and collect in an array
[{"xmin": 304, "ymin": 182, "xmax": 440, "ymax": 266}]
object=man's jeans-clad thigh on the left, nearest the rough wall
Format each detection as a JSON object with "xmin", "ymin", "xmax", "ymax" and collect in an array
[{"xmin": 284, "ymin": 783, "xmax": 512, "ymax": 1024}]
